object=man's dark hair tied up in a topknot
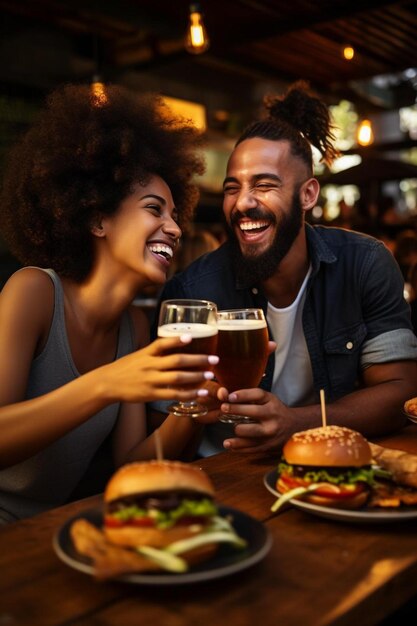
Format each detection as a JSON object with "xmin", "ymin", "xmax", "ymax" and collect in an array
[{"xmin": 236, "ymin": 81, "xmax": 339, "ymax": 172}]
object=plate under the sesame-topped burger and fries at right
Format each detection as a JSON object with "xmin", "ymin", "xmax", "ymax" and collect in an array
[{"xmin": 264, "ymin": 469, "xmax": 417, "ymax": 524}]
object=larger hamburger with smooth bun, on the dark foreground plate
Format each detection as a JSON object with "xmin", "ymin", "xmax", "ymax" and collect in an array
[{"xmin": 103, "ymin": 461, "xmax": 245, "ymax": 571}]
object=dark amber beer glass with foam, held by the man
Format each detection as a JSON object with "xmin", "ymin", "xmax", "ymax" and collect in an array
[{"xmin": 214, "ymin": 309, "xmax": 268, "ymax": 424}]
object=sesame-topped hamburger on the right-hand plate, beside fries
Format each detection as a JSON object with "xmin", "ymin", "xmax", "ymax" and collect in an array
[{"xmin": 272, "ymin": 426, "xmax": 374, "ymax": 511}]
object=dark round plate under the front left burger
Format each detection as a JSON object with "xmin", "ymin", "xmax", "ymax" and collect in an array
[{"xmin": 53, "ymin": 506, "xmax": 272, "ymax": 586}]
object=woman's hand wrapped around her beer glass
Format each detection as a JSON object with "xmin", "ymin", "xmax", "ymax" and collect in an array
[{"xmin": 100, "ymin": 335, "xmax": 218, "ymax": 402}]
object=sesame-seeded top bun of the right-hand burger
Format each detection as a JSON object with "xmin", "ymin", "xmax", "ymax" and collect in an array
[{"xmin": 283, "ymin": 426, "xmax": 372, "ymax": 467}]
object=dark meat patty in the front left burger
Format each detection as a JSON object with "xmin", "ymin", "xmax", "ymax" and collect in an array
[{"xmin": 107, "ymin": 490, "xmax": 211, "ymax": 514}]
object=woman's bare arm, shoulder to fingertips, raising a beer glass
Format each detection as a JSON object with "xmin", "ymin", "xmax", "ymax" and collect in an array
[{"xmin": 0, "ymin": 270, "xmax": 219, "ymax": 467}]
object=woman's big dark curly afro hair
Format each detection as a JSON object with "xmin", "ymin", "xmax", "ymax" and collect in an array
[{"xmin": 0, "ymin": 85, "xmax": 204, "ymax": 281}]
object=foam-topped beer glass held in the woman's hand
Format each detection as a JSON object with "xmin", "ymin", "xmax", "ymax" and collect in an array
[{"xmin": 158, "ymin": 299, "xmax": 217, "ymax": 417}]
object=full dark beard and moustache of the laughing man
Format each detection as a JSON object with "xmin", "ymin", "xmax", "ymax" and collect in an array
[{"xmin": 227, "ymin": 189, "xmax": 303, "ymax": 286}]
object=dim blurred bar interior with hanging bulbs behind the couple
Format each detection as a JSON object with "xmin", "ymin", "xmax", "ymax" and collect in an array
[{"xmin": 0, "ymin": 0, "xmax": 417, "ymax": 307}]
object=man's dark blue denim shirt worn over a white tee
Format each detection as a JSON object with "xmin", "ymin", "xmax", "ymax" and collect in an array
[{"xmin": 160, "ymin": 224, "xmax": 417, "ymax": 401}]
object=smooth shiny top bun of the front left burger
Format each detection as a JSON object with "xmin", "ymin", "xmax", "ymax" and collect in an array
[{"xmin": 104, "ymin": 461, "xmax": 214, "ymax": 503}]
